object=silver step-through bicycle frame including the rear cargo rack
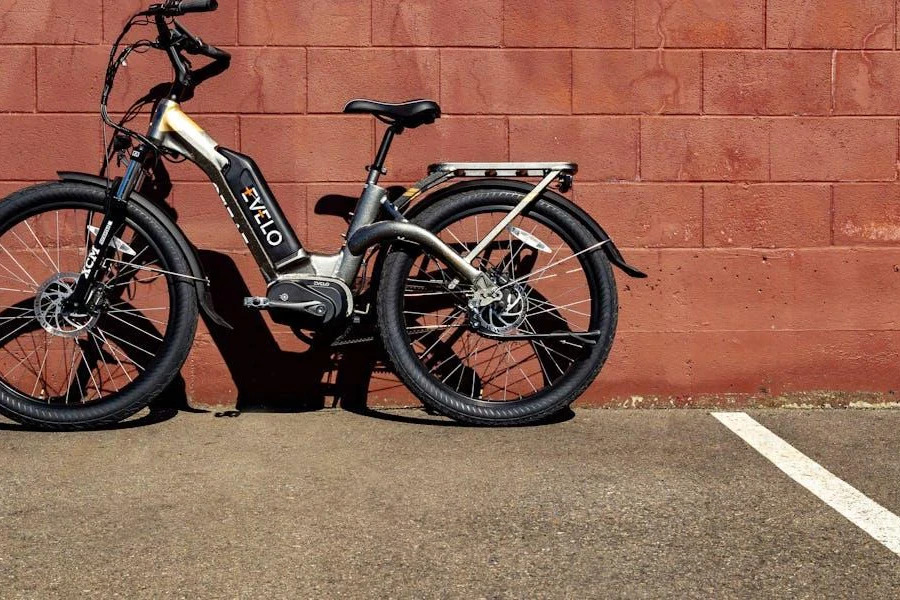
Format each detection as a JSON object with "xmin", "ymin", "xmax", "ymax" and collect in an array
[{"xmin": 110, "ymin": 99, "xmax": 576, "ymax": 301}]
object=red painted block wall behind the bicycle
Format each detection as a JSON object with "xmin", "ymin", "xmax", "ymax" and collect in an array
[{"xmin": 0, "ymin": 0, "xmax": 900, "ymax": 404}]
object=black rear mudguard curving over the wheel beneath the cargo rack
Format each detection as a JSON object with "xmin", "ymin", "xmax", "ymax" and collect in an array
[{"xmin": 404, "ymin": 178, "xmax": 647, "ymax": 279}]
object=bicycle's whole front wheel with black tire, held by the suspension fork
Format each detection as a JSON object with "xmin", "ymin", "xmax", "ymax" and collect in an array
[{"xmin": 0, "ymin": 182, "xmax": 197, "ymax": 429}]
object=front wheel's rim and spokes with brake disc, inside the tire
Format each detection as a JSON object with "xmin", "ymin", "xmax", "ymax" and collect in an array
[{"xmin": 0, "ymin": 203, "xmax": 172, "ymax": 406}]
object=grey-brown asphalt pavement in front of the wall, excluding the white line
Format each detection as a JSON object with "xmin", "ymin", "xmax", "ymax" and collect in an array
[{"xmin": 0, "ymin": 410, "xmax": 900, "ymax": 599}]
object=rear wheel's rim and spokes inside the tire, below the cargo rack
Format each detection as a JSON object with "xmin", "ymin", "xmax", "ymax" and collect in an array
[{"xmin": 402, "ymin": 206, "xmax": 600, "ymax": 403}]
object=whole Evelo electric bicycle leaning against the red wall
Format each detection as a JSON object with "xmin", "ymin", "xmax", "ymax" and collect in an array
[{"xmin": 0, "ymin": 0, "xmax": 645, "ymax": 430}]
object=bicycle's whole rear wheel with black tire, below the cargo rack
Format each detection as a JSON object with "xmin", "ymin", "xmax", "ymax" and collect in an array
[{"xmin": 378, "ymin": 189, "xmax": 618, "ymax": 425}]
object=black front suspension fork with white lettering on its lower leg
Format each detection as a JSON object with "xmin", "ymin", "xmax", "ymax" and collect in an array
[{"xmin": 66, "ymin": 144, "xmax": 155, "ymax": 311}]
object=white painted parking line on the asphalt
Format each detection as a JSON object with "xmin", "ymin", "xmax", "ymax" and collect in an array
[{"xmin": 712, "ymin": 413, "xmax": 900, "ymax": 555}]
